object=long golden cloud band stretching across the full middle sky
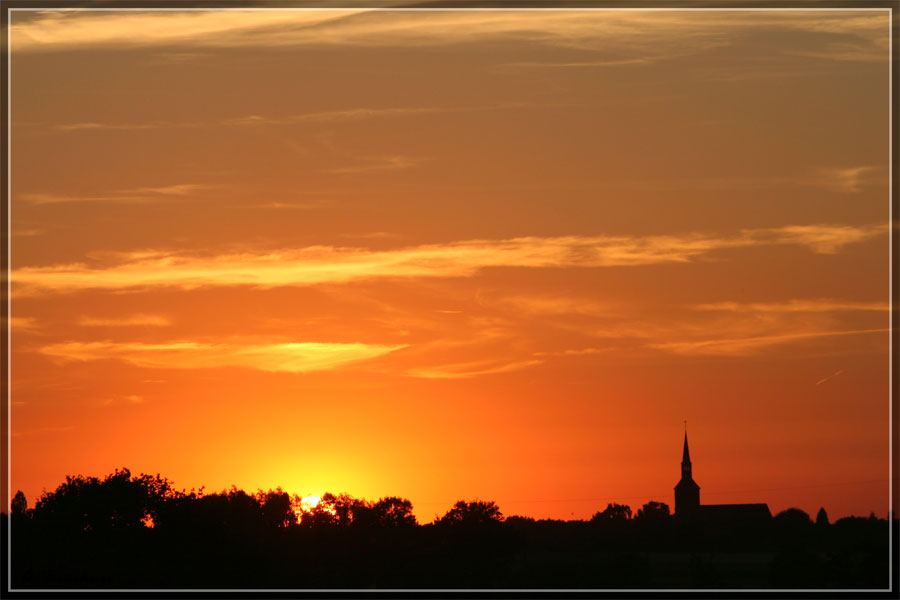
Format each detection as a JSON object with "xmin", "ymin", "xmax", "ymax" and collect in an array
[{"xmin": 12, "ymin": 225, "xmax": 887, "ymax": 294}]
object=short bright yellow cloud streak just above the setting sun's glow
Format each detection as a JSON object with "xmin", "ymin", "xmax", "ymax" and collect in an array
[{"xmin": 38, "ymin": 341, "xmax": 405, "ymax": 373}]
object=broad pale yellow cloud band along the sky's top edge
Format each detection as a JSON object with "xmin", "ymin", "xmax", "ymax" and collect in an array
[{"xmin": 10, "ymin": 9, "xmax": 889, "ymax": 61}]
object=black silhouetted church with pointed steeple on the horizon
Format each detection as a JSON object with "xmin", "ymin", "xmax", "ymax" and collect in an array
[{"xmin": 675, "ymin": 432, "xmax": 772, "ymax": 527}]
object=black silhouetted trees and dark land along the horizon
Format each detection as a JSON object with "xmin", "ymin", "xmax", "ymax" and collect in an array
[{"xmin": 3, "ymin": 469, "xmax": 896, "ymax": 589}]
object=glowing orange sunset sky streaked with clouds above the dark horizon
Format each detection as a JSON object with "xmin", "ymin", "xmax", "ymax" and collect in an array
[{"xmin": 6, "ymin": 9, "xmax": 891, "ymax": 522}]
